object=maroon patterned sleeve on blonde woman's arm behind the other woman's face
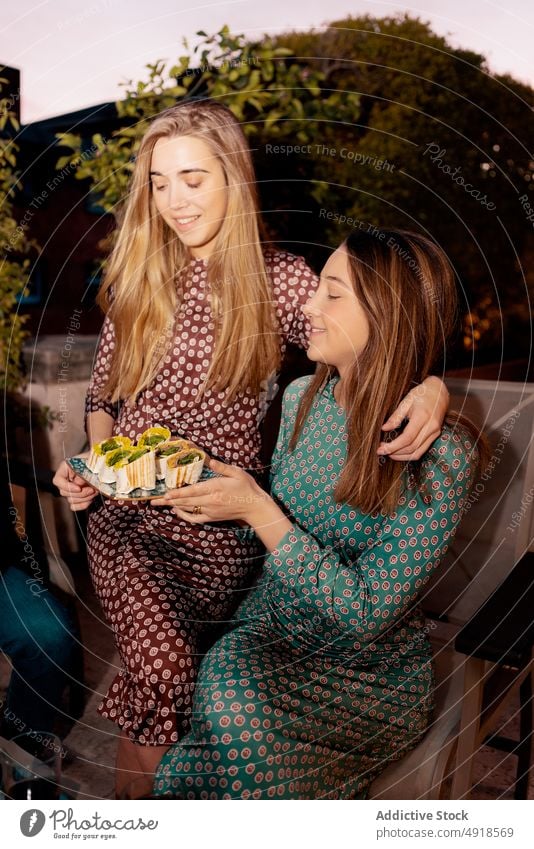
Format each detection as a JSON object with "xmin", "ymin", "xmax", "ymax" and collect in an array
[{"xmin": 270, "ymin": 254, "xmax": 319, "ymax": 348}]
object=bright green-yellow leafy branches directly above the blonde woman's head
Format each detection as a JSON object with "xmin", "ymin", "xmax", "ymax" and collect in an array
[{"xmin": 57, "ymin": 27, "xmax": 358, "ymax": 219}]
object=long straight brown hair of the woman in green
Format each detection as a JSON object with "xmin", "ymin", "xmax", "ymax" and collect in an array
[{"xmin": 290, "ymin": 229, "xmax": 479, "ymax": 513}]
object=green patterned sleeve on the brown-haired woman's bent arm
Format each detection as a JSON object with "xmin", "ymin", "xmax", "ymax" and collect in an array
[{"xmin": 265, "ymin": 429, "xmax": 480, "ymax": 647}]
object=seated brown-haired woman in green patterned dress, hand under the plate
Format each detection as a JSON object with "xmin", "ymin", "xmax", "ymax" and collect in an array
[{"xmin": 155, "ymin": 231, "xmax": 477, "ymax": 799}]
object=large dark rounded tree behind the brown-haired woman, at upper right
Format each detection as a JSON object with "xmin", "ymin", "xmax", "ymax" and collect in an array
[{"xmin": 276, "ymin": 15, "xmax": 534, "ymax": 356}]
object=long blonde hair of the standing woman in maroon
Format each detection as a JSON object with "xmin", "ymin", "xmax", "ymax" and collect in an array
[{"xmin": 98, "ymin": 100, "xmax": 280, "ymax": 402}]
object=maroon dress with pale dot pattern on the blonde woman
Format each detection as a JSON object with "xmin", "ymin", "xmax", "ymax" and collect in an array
[{"xmin": 86, "ymin": 251, "xmax": 317, "ymax": 745}]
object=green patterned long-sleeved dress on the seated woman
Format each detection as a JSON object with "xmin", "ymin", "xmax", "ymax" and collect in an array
[{"xmin": 155, "ymin": 378, "xmax": 478, "ymax": 799}]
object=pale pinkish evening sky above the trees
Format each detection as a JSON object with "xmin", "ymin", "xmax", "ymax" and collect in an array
[{"xmin": 0, "ymin": 0, "xmax": 534, "ymax": 123}]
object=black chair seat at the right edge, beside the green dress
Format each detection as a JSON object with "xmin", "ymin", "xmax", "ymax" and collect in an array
[{"xmin": 454, "ymin": 552, "xmax": 534, "ymax": 669}]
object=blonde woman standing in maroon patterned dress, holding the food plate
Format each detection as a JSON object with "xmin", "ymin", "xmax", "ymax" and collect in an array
[{"xmin": 55, "ymin": 101, "xmax": 448, "ymax": 791}]
